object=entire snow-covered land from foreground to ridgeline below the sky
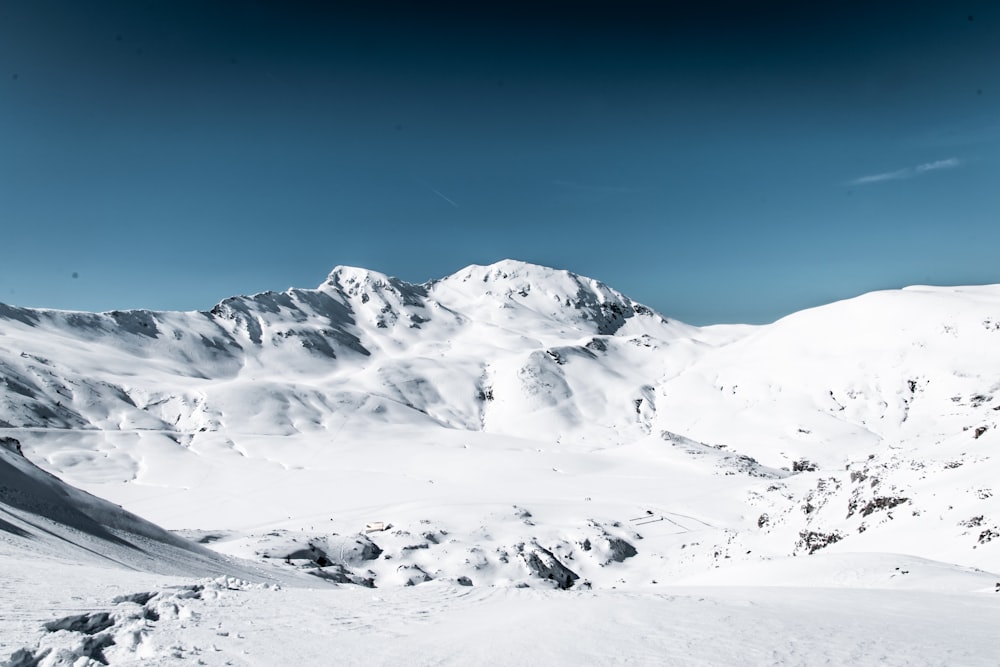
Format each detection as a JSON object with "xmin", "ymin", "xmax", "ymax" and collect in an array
[{"xmin": 0, "ymin": 261, "xmax": 1000, "ymax": 665}]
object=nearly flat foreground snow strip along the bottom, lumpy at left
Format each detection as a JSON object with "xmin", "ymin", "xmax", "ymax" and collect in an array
[{"xmin": 11, "ymin": 569, "xmax": 1000, "ymax": 667}]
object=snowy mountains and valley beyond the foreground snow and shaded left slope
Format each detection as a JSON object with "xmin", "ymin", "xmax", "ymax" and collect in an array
[{"xmin": 0, "ymin": 261, "xmax": 1000, "ymax": 667}]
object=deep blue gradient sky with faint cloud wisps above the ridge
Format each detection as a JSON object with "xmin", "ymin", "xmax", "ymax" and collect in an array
[{"xmin": 0, "ymin": 0, "xmax": 1000, "ymax": 324}]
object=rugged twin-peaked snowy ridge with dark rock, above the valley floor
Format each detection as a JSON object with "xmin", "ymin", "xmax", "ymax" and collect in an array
[{"xmin": 0, "ymin": 262, "xmax": 711, "ymax": 435}]
